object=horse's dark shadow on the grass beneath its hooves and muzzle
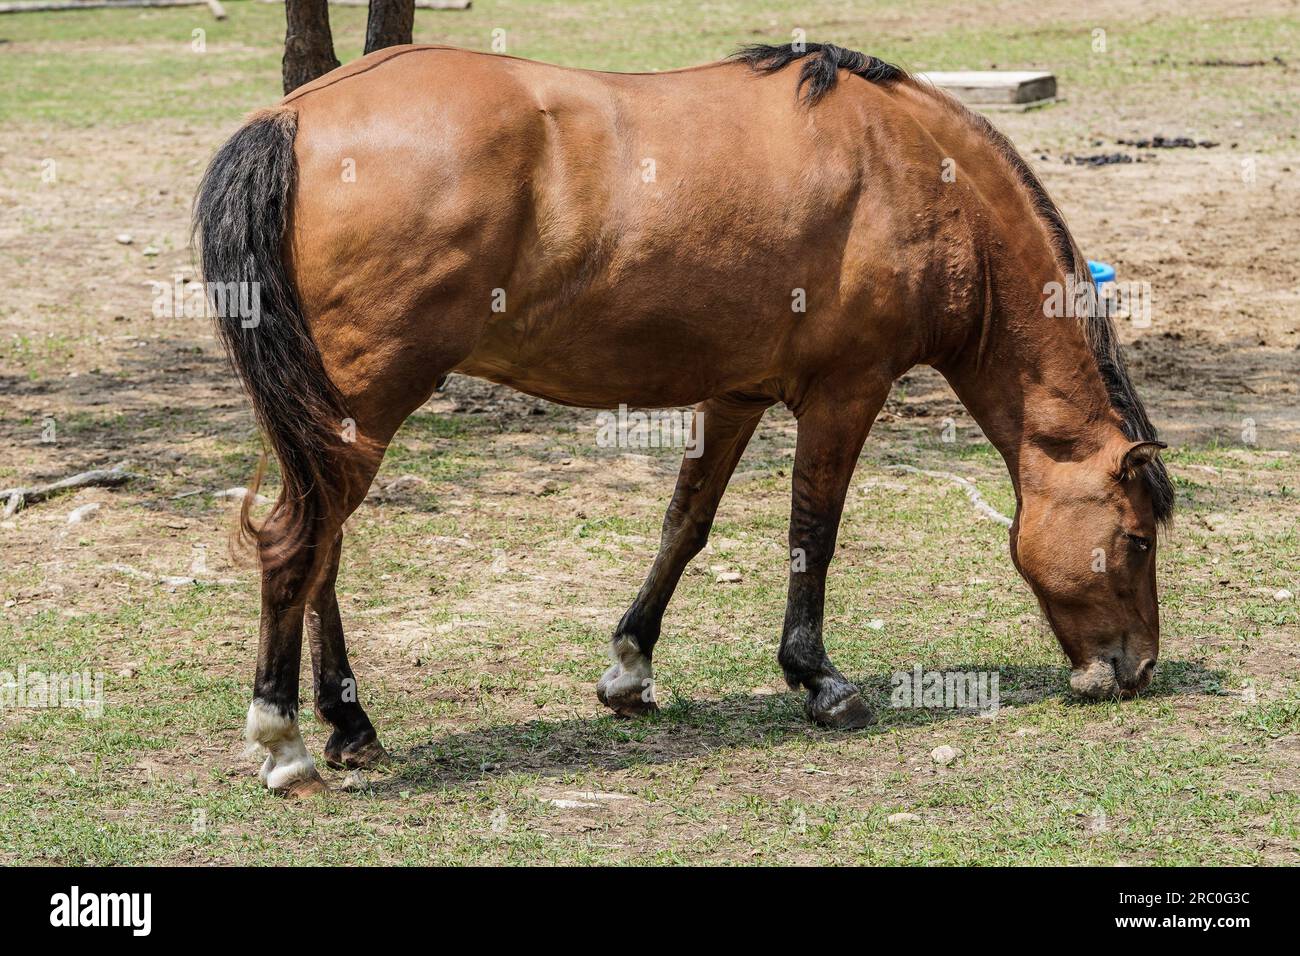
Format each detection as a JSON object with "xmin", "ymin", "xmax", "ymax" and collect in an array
[{"xmin": 372, "ymin": 661, "xmax": 1226, "ymax": 797}]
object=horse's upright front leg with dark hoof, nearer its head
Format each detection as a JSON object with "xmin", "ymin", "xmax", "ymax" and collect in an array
[{"xmin": 779, "ymin": 382, "xmax": 889, "ymax": 728}]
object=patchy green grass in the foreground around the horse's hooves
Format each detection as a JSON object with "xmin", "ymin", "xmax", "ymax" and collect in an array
[{"xmin": 0, "ymin": 400, "xmax": 1300, "ymax": 865}]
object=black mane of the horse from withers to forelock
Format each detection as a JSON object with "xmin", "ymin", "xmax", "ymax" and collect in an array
[{"xmin": 732, "ymin": 43, "xmax": 1174, "ymax": 524}]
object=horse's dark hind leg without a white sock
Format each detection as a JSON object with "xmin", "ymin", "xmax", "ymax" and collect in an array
[{"xmin": 303, "ymin": 533, "xmax": 389, "ymax": 769}]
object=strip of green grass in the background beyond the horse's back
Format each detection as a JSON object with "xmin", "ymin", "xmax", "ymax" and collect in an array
[{"xmin": 0, "ymin": 0, "xmax": 1300, "ymax": 135}]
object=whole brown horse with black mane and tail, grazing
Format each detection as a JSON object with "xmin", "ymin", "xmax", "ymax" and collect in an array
[{"xmin": 195, "ymin": 44, "xmax": 1173, "ymax": 795}]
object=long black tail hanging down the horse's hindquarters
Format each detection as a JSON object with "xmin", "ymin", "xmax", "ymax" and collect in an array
[{"xmin": 194, "ymin": 108, "xmax": 355, "ymax": 567}]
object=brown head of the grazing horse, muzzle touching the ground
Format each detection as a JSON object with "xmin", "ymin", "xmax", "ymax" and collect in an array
[{"xmin": 1011, "ymin": 436, "xmax": 1165, "ymax": 697}]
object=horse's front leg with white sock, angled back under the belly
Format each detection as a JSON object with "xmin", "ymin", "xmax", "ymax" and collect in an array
[{"xmin": 595, "ymin": 395, "xmax": 771, "ymax": 717}]
